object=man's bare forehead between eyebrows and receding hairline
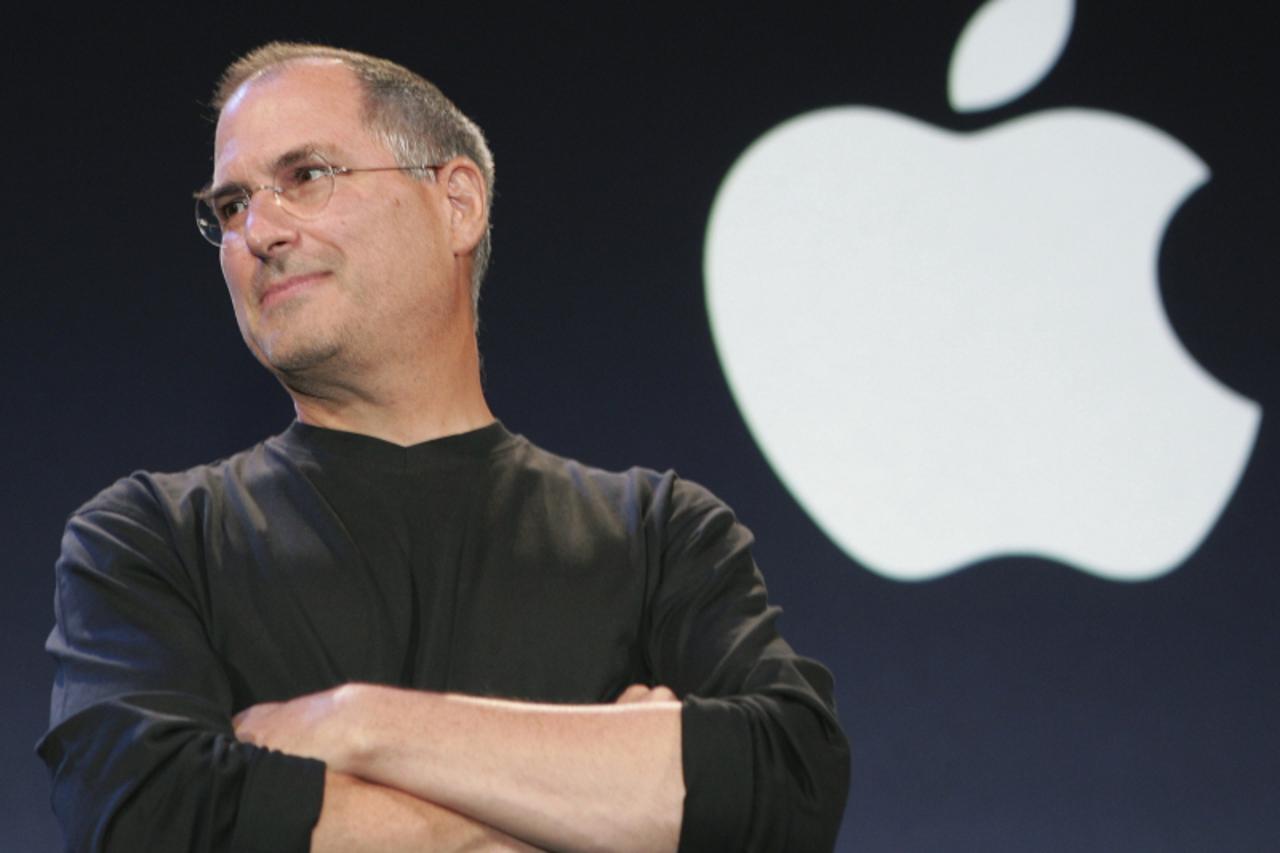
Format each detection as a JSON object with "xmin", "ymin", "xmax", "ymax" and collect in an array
[{"xmin": 214, "ymin": 60, "xmax": 385, "ymax": 183}]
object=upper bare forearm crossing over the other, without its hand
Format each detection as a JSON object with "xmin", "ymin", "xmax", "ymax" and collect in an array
[{"xmin": 330, "ymin": 685, "xmax": 685, "ymax": 850}]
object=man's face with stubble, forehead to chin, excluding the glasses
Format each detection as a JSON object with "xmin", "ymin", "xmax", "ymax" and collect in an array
[{"xmin": 214, "ymin": 60, "xmax": 460, "ymax": 379}]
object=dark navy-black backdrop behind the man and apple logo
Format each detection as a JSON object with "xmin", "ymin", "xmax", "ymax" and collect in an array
[{"xmin": 0, "ymin": 0, "xmax": 1280, "ymax": 852}]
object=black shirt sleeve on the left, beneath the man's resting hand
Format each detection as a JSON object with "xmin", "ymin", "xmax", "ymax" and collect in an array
[{"xmin": 37, "ymin": 479, "xmax": 324, "ymax": 853}]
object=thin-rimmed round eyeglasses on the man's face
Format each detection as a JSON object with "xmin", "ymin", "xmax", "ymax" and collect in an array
[{"xmin": 196, "ymin": 152, "xmax": 440, "ymax": 246}]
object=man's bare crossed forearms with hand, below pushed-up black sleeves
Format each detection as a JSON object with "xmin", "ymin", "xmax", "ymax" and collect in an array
[{"xmin": 234, "ymin": 684, "xmax": 685, "ymax": 850}]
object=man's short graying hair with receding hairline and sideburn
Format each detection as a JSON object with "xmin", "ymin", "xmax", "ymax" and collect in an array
[{"xmin": 212, "ymin": 41, "xmax": 494, "ymax": 307}]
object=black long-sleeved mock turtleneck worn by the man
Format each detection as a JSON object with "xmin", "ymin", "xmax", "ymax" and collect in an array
[{"xmin": 38, "ymin": 423, "xmax": 849, "ymax": 850}]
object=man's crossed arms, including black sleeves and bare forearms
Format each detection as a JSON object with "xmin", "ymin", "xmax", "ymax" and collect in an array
[{"xmin": 38, "ymin": 473, "xmax": 849, "ymax": 853}]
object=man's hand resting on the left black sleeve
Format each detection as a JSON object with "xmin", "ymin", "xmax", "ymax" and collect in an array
[{"xmin": 232, "ymin": 685, "xmax": 356, "ymax": 770}]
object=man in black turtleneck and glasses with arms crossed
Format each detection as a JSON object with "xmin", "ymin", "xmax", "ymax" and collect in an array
[{"xmin": 38, "ymin": 44, "xmax": 847, "ymax": 850}]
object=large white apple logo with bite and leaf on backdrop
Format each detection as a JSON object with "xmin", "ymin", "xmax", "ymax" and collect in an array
[{"xmin": 705, "ymin": 0, "xmax": 1261, "ymax": 580}]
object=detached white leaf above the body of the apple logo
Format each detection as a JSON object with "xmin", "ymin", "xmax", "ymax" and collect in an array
[{"xmin": 947, "ymin": 0, "xmax": 1075, "ymax": 113}]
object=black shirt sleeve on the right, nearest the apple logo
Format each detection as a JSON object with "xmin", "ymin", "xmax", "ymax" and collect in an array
[{"xmin": 649, "ymin": 480, "xmax": 849, "ymax": 852}]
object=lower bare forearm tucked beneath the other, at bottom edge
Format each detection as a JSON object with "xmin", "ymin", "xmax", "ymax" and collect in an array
[{"xmin": 311, "ymin": 770, "xmax": 538, "ymax": 853}]
